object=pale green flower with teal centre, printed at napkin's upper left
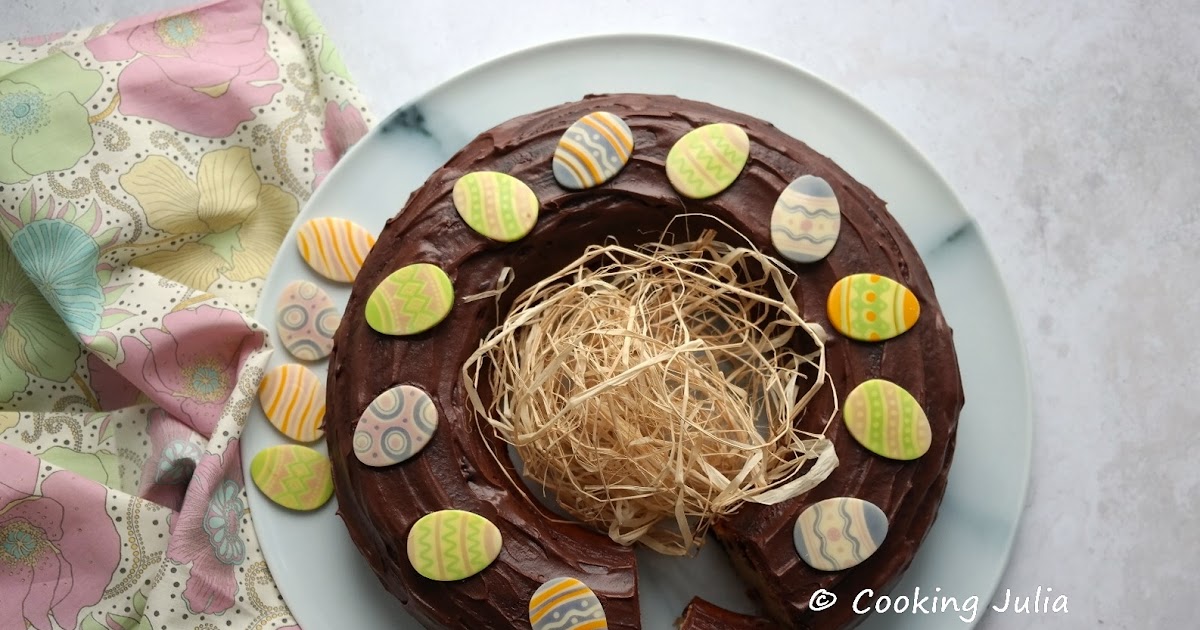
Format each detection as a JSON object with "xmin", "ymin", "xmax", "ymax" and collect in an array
[{"xmin": 0, "ymin": 52, "xmax": 101, "ymax": 184}]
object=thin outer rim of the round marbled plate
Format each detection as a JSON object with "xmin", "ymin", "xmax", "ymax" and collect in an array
[{"xmin": 239, "ymin": 32, "xmax": 1034, "ymax": 628}]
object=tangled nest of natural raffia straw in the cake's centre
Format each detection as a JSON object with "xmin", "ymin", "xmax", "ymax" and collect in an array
[{"xmin": 463, "ymin": 223, "xmax": 838, "ymax": 556}]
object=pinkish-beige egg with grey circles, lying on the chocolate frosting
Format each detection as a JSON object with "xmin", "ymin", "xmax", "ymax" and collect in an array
[{"xmin": 354, "ymin": 385, "xmax": 438, "ymax": 467}]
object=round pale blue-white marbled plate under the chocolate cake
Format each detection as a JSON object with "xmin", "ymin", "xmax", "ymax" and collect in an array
[{"xmin": 242, "ymin": 35, "xmax": 1032, "ymax": 630}]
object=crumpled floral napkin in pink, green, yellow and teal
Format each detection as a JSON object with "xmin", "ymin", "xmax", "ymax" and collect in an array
[{"xmin": 0, "ymin": 0, "xmax": 371, "ymax": 630}]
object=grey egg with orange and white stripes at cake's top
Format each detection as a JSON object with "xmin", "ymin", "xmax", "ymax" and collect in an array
[{"xmin": 552, "ymin": 112, "xmax": 634, "ymax": 191}]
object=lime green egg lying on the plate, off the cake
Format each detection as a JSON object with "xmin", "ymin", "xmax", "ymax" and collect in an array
[{"xmin": 250, "ymin": 444, "xmax": 334, "ymax": 510}]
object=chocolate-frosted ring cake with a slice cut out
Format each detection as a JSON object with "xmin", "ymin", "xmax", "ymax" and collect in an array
[{"xmin": 325, "ymin": 94, "xmax": 964, "ymax": 629}]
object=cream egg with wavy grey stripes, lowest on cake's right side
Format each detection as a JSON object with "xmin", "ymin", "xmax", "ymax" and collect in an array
[{"xmin": 792, "ymin": 497, "xmax": 888, "ymax": 571}]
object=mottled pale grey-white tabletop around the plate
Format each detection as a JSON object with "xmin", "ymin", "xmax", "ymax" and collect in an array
[{"xmin": 0, "ymin": 0, "xmax": 1200, "ymax": 630}]
